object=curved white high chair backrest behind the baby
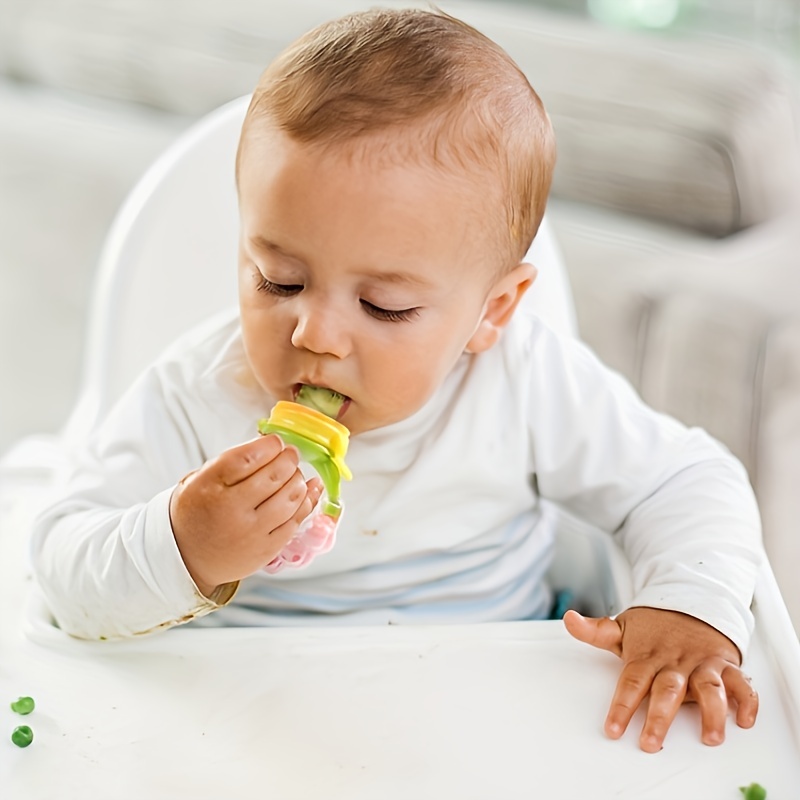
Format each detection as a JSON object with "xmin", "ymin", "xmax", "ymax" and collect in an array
[{"xmin": 65, "ymin": 96, "xmax": 575, "ymax": 437}]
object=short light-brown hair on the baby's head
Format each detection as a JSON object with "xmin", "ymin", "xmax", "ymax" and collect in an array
[{"xmin": 237, "ymin": 9, "xmax": 555, "ymax": 265}]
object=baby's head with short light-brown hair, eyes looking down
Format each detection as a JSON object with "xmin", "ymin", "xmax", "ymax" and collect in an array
[{"xmin": 237, "ymin": 10, "xmax": 555, "ymax": 433}]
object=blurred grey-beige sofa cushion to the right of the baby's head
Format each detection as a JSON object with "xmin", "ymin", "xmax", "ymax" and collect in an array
[{"xmin": 466, "ymin": 6, "xmax": 800, "ymax": 236}]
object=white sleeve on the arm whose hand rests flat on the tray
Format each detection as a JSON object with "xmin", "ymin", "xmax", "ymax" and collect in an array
[{"xmin": 527, "ymin": 322, "xmax": 763, "ymax": 653}]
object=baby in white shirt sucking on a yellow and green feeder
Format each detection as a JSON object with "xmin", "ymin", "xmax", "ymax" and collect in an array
[{"xmin": 33, "ymin": 10, "xmax": 761, "ymax": 752}]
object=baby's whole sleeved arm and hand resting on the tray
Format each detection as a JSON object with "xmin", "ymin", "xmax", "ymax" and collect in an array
[{"xmin": 531, "ymin": 320, "xmax": 763, "ymax": 750}]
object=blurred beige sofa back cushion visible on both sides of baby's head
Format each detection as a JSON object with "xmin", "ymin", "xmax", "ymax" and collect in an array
[{"xmin": 0, "ymin": 0, "xmax": 800, "ymax": 236}]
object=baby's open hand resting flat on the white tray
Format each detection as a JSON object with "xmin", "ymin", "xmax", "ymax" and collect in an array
[{"xmin": 564, "ymin": 608, "xmax": 758, "ymax": 753}]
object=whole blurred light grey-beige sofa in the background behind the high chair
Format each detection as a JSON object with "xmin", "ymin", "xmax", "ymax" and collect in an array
[{"xmin": 0, "ymin": 0, "xmax": 800, "ymax": 629}]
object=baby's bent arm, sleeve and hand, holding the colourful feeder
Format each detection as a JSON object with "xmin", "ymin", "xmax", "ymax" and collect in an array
[{"xmin": 31, "ymin": 354, "xmax": 319, "ymax": 639}]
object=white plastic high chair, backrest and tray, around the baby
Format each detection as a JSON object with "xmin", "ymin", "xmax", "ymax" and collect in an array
[{"xmin": 0, "ymin": 98, "xmax": 800, "ymax": 800}]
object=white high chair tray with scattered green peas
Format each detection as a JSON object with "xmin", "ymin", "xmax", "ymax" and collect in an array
[{"xmin": 0, "ymin": 584, "xmax": 800, "ymax": 800}]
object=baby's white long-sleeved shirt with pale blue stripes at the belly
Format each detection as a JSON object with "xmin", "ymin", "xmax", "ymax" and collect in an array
[{"xmin": 32, "ymin": 312, "xmax": 762, "ymax": 651}]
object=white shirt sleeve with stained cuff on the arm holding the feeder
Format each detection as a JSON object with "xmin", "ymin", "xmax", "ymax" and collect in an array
[{"xmin": 31, "ymin": 360, "xmax": 241, "ymax": 639}]
